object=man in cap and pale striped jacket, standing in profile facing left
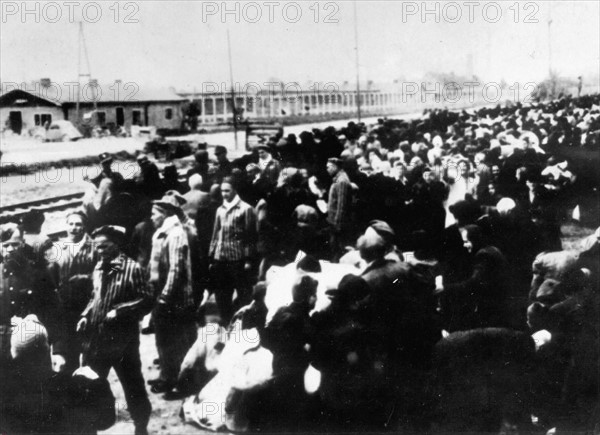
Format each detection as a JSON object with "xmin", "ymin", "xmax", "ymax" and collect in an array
[{"xmin": 149, "ymin": 195, "xmax": 197, "ymax": 397}]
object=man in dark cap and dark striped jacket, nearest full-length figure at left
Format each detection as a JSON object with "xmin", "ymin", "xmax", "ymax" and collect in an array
[{"xmin": 77, "ymin": 225, "xmax": 152, "ymax": 434}]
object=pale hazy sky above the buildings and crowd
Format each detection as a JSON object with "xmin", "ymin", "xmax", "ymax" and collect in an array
[{"xmin": 0, "ymin": 1, "xmax": 600, "ymax": 90}]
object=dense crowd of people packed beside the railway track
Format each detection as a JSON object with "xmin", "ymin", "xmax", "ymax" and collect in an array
[{"xmin": 0, "ymin": 96, "xmax": 600, "ymax": 434}]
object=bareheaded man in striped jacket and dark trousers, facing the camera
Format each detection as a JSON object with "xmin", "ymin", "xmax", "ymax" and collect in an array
[{"xmin": 209, "ymin": 177, "xmax": 257, "ymax": 324}]
